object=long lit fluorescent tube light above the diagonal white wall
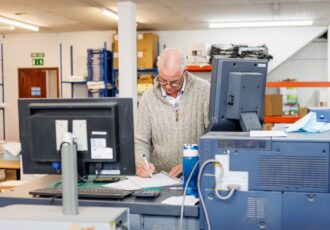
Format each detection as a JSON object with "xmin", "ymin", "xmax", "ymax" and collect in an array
[{"xmin": 209, "ymin": 20, "xmax": 313, "ymax": 29}]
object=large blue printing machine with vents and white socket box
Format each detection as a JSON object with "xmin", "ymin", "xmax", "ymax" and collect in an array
[{"xmin": 199, "ymin": 132, "xmax": 330, "ymax": 230}]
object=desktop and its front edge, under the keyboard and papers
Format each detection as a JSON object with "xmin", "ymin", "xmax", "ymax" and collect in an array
[{"xmin": 0, "ymin": 175, "xmax": 199, "ymax": 218}]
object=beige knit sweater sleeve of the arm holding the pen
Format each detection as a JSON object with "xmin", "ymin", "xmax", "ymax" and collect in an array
[{"xmin": 135, "ymin": 93, "xmax": 152, "ymax": 164}]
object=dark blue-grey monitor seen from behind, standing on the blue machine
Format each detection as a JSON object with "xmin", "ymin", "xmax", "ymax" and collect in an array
[{"xmin": 208, "ymin": 56, "xmax": 268, "ymax": 131}]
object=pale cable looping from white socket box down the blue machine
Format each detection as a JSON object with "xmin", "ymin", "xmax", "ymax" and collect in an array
[{"xmin": 197, "ymin": 159, "xmax": 238, "ymax": 230}]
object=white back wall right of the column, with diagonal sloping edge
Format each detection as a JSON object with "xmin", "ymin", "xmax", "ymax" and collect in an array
[{"xmin": 156, "ymin": 27, "xmax": 328, "ymax": 106}]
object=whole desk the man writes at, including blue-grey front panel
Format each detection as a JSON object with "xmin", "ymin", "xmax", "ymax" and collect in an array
[{"xmin": 0, "ymin": 175, "xmax": 199, "ymax": 229}]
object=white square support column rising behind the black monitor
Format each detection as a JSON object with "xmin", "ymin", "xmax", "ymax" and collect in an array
[{"xmin": 118, "ymin": 1, "xmax": 137, "ymax": 119}]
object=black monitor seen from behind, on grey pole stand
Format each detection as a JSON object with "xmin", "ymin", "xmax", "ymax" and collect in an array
[{"xmin": 18, "ymin": 98, "xmax": 135, "ymax": 176}]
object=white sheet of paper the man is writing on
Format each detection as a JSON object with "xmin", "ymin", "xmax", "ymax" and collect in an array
[{"xmin": 127, "ymin": 173, "xmax": 181, "ymax": 188}]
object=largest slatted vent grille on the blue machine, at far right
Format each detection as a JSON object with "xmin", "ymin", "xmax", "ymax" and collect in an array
[{"xmin": 259, "ymin": 156, "xmax": 328, "ymax": 189}]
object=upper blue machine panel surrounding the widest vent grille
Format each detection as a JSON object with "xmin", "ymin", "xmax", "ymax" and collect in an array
[{"xmin": 230, "ymin": 142, "xmax": 329, "ymax": 192}]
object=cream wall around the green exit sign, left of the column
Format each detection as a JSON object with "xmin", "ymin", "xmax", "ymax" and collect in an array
[{"xmin": 3, "ymin": 31, "xmax": 114, "ymax": 141}]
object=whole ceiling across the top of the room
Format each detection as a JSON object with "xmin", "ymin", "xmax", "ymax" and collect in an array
[{"xmin": 0, "ymin": 0, "xmax": 330, "ymax": 34}]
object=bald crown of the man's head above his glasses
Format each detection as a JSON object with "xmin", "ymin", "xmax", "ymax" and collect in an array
[{"xmin": 157, "ymin": 48, "xmax": 184, "ymax": 72}]
